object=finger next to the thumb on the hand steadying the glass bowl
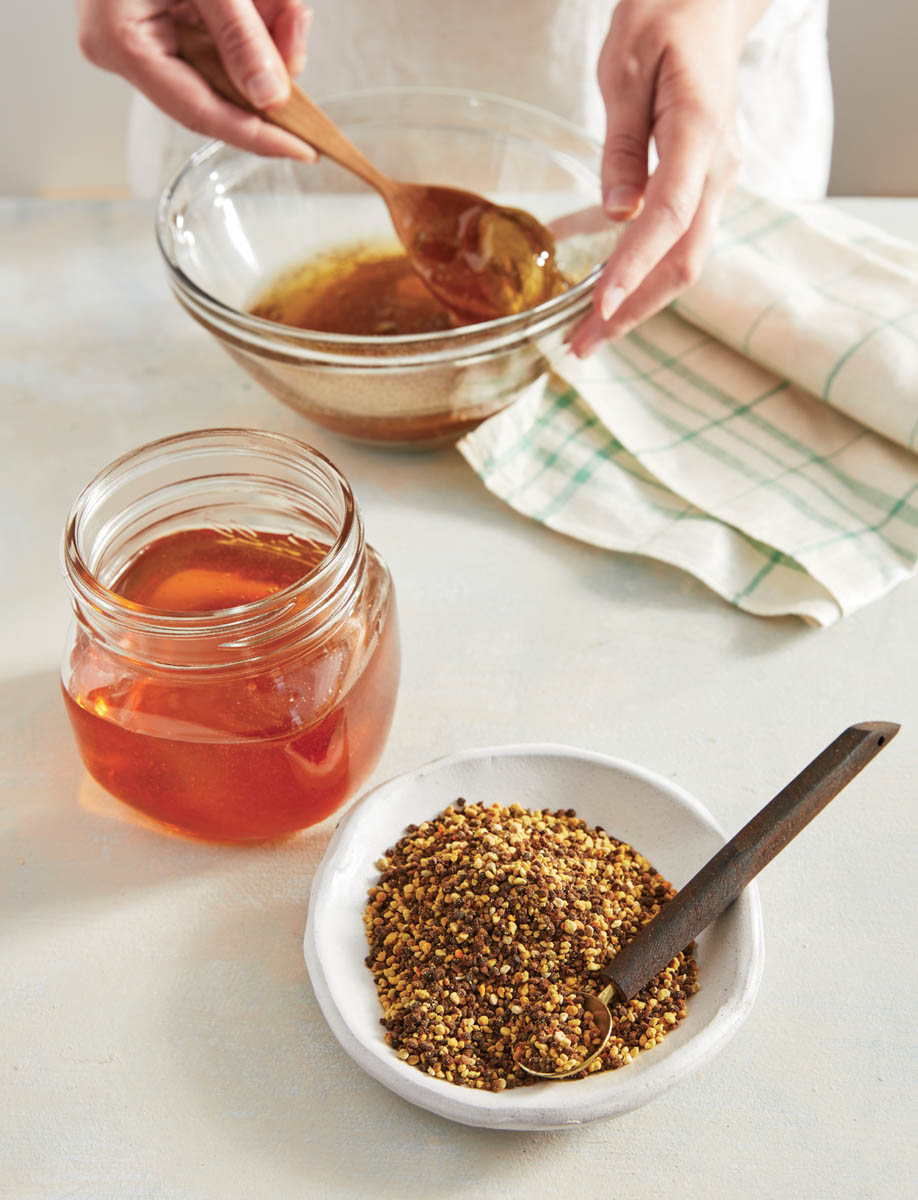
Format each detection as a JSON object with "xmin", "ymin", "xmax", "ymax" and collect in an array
[{"xmin": 594, "ymin": 96, "xmax": 716, "ymax": 322}]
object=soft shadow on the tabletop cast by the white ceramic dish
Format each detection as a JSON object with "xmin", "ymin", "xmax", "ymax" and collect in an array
[{"xmin": 164, "ymin": 876, "xmax": 582, "ymax": 1198}]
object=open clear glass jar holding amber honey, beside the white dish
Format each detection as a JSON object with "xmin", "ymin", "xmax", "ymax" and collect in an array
[{"xmin": 62, "ymin": 430, "xmax": 400, "ymax": 841}]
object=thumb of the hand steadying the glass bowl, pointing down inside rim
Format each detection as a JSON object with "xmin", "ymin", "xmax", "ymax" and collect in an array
[{"xmin": 600, "ymin": 55, "xmax": 653, "ymax": 221}]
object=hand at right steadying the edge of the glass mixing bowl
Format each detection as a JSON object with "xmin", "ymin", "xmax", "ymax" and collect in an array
[{"xmin": 570, "ymin": 0, "xmax": 768, "ymax": 358}]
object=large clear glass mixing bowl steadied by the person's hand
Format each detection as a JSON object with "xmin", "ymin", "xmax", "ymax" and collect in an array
[{"xmin": 157, "ymin": 88, "xmax": 606, "ymax": 444}]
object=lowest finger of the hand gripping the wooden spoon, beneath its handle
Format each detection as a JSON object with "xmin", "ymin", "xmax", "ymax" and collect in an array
[{"xmin": 130, "ymin": 54, "xmax": 317, "ymax": 162}]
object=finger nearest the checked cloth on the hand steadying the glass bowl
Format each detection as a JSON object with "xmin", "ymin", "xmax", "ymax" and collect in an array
[{"xmin": 570, "ymin": 136, "xmax": 738, "ymax": 359}]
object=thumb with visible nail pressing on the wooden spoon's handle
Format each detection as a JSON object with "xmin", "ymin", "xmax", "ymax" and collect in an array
[{"xmin": 197, "ymin": 0, "xmax": 290, "ymax": 108}]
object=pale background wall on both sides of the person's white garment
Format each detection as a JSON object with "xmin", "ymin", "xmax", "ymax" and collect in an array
[{"xmin": 0, "ymin": 0, "xmax": 918, "ymax": 196}]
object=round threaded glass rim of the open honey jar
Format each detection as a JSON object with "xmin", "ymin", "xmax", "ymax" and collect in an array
[{"xmin": 62, "ymin": 427, "xmax": 362, "ymax": 644}]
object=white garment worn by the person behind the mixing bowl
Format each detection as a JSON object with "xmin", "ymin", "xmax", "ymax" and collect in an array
[{"xmin": 128, "ymin": 0, "xmax": 832, "ymax": 199}]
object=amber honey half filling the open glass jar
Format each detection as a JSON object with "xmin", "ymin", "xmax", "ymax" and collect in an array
[{"xmin": 64, "ymin": 431, "xmax": 398, "ymax": 841}]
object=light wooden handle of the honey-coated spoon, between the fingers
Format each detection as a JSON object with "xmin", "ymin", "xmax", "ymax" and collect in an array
[{"xmin": 175, "ymin": 22, "xmax": 390, "ymax": 196}]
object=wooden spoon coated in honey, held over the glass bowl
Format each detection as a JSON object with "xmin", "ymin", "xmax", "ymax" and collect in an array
[{"xmin": 178, "ymin": 23, "xmax": 565, "ymax": 320}]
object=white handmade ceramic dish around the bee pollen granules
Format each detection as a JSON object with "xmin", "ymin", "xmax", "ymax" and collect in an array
[{"xmin": 304, "ymin": 745, "xmax": 764, "ymax": 1129}]
